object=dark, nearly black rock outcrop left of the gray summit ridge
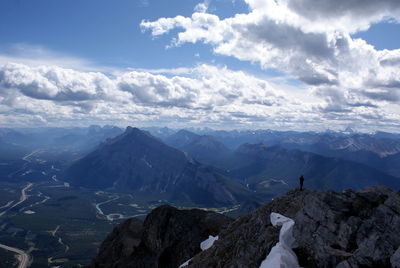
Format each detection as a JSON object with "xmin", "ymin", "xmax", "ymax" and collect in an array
[{"xmin": 91, "ymin": 206, "xmax": 233, "ymax": 268}]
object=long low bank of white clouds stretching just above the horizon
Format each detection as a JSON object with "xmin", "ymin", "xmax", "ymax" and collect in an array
[{"xmin": 0, "ymin": 53, "xmax": 399, "ymax": 130}]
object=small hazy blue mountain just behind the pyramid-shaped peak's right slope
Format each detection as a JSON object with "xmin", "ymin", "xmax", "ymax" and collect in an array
[{"xmin": 165, "ymin": 130, "xmax": 232, "ymax": 166}]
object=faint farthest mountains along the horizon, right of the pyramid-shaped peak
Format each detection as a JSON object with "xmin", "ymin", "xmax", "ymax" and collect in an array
[{"xmin": 154, "ymin": 129, "xmax": 400, "ymax": 180}]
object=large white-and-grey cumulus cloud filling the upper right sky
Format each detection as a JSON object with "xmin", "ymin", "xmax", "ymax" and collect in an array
[{"xmin": 141, "ymin": 0, "xmax": 400, "ymax": 124}]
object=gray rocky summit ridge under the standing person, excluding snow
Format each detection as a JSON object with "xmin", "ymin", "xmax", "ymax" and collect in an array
[{"xmin": 188, "ymin": 187, "xmax": 400, "ymax": 267}]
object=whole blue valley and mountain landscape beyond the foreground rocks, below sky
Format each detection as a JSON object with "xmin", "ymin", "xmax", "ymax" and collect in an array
[{"xmin": 0, "ymin": 126, "xmax": 400, "ymax": 268}]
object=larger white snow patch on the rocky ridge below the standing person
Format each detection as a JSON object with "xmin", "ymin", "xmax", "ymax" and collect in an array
[{"xmin": 260, "ymin": 212, "xmax": 300, "ymax": 268}]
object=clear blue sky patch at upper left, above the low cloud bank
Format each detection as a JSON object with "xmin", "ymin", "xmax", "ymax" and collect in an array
[{"xmin": 0, "ymin": 0, "xmax": 247, "ymax": 68}]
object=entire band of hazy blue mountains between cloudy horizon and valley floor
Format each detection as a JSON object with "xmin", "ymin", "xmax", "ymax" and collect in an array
[{"xmin": 0, "ymin": 126, "xmax": 400, "ymax": 206}]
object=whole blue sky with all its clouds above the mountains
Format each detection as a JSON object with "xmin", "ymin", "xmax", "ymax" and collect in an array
[{"xmin": 0, "ymin": 0, "xmax": 400, "ymax": 132}]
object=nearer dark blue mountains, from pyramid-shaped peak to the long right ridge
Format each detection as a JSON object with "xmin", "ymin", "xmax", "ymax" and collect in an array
[{"xmin": 64, "ymin": 127, "xmax": 400, "ymax": 206}]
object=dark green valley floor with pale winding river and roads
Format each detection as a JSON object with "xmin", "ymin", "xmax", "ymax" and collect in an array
[{"xmin": 0, "ymin": 150, "xmax": 238, "ymax": 268}]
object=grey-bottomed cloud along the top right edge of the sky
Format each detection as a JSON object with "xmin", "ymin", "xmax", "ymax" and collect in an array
[{"xmin": 245, "ymin": 0, "xmax": 400, "ymax": 33}]
